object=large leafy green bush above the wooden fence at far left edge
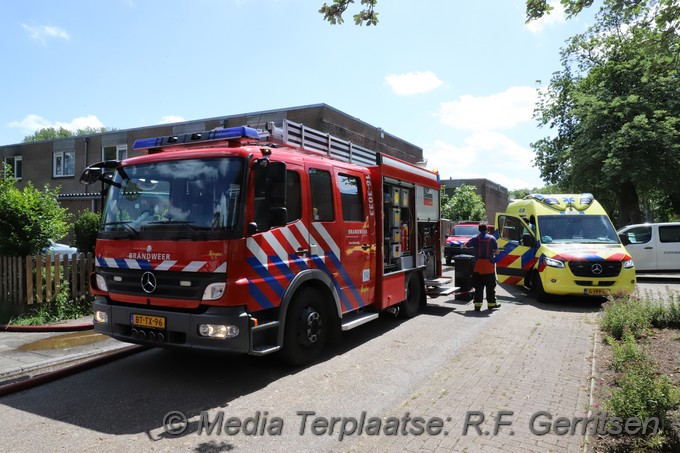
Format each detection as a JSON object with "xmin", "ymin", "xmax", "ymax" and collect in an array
[{"xmin": 0, "ymin": 165, "xmax": 69, "ymax": 256}]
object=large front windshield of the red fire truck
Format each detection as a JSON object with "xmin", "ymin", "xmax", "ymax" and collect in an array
[{"xmin": 100, "ymin": 157, "xmax": 244, "ymax": 240}]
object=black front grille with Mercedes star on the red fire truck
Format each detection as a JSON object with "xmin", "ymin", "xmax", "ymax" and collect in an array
[{"xmin": 97, "ymin": 268, "xmax": 226, "ymax": 300}]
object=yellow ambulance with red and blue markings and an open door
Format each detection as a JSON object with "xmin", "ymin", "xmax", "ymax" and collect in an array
[{"xmin": 494, "ymin": 193, "xmax": 636, "ymax": 302}]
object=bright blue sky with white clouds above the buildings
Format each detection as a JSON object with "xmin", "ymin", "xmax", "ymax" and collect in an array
[{"xmin": 0, "ymin": 0, "xmax": 599, "ymax": 190}]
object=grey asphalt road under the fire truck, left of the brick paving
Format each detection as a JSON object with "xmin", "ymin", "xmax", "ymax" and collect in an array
[{"xmin": 0, "ymin": 272, "xmax": 680, "ymax": 452}]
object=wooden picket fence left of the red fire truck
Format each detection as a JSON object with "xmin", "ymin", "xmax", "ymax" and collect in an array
[{"xmin": 0, "ymin": 253, "xmax": 94, "ymax": 305}]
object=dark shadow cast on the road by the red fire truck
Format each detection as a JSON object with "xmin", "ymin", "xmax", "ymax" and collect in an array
[{"xmin": 0, "ymin": 313, "xmax": 412, "ymax": 440}]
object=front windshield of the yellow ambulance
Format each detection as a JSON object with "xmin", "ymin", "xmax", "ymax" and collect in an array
[{"xmin": 538, "ymin": 214, "xmax": 619, "ymax": 244}]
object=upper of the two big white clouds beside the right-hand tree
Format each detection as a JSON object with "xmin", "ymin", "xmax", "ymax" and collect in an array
[{"xmin": 439, "ymin": 87, "xmax": 538, "ymax": 131}]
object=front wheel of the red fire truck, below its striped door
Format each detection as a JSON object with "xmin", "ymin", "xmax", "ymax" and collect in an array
[{"xmin": 282, "ymin": 288, "xmax": 330, "ymax": 366}]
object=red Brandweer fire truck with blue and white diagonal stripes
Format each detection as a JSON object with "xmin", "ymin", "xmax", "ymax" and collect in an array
[{"xmin": 81, "ymin": 121, "xmax": 454, "ymax": 364}]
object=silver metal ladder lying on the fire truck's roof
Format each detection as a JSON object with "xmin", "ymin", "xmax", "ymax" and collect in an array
[{"xmin": 267, "ymin": 120, "xmax": 380, "ymax": 166}]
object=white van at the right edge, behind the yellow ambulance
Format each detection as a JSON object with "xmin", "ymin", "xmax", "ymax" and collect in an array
[{"xmin": 619, "ymin": 222, "xmax": 680, "ymax": 272}]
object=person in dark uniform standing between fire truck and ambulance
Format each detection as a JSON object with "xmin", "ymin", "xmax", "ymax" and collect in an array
[{"xmin": 465, "ymin": 223, "xmax": 501, "ymax": 311}]
